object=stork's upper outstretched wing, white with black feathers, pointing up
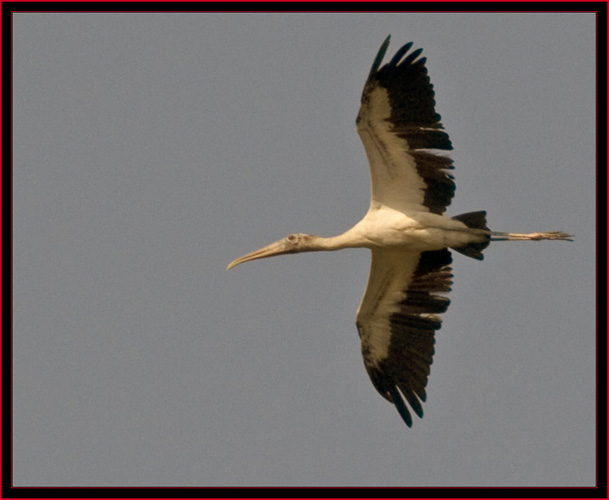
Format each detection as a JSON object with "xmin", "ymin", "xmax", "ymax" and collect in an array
[{"xmin": 356, "ymin": 37, "xmax": 455, "ymax": 214}]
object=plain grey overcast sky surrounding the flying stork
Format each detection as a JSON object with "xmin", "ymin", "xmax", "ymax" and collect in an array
[{"xmin": 13, "ymin": 14, "xmax": 595, "ymax": 486}]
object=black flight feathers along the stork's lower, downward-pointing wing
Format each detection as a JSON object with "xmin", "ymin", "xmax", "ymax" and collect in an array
[{"xmin": 364, "ymin": 249, "xmax": 452, "ymax": 427}]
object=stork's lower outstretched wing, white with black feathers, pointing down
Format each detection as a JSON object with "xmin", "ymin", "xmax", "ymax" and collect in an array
[{"xmin": 357, "ymin": 249, "xmax": 452, "ymax": 427}]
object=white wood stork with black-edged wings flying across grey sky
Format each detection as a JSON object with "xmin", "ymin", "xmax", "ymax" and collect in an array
[{"xmin": 227, "ymin": 36, "xmax": 571, "ymax": 427}]
